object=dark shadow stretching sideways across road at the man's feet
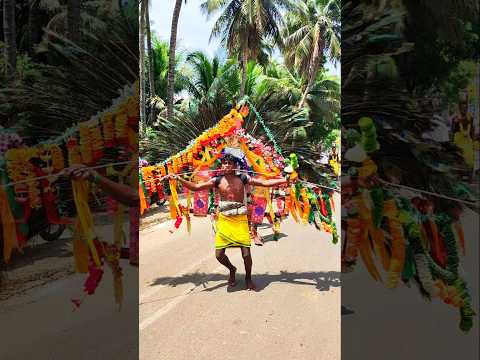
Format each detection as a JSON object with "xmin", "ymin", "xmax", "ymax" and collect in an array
[{"xmin": 150, "ymin": 271, "xmax": 341, "ymax": 292}]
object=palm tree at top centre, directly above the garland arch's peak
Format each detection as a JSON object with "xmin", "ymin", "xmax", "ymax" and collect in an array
[{"xmin": 201, "ymin": 0, "xmax": 288, "ymax": 97}]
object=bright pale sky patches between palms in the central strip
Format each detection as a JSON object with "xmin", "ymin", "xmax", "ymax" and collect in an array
[{"xmin": 150, "ymin": 0, "xmax": 340, "ymax": 76}]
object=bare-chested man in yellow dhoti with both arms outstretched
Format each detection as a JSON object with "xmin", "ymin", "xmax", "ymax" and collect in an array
[{"xmin": 172, "ymin": 155, "xmax": 289, "ymax": 291}]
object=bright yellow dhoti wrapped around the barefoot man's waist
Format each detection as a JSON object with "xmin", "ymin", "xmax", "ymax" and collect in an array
[{"xmin": 215, "ymin": 213, "xmax": 250, "ymax": 249}]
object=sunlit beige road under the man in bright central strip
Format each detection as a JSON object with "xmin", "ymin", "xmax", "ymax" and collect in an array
[{"xmin": 140, "ymin": 197, "xmax": 340, "ymax": 360}]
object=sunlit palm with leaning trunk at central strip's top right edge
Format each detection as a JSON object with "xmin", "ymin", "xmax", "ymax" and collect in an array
[{"xmin": 283, "ymin": 0, "xmax": 340, "ymax": 108}]
